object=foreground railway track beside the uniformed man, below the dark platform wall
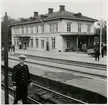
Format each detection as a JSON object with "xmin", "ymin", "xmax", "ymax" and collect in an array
[{"xmin": 1, "ymin": 71, "xmax": 86, "ymax": 104}]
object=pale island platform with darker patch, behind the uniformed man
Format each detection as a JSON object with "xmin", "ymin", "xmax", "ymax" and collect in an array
[{"xmin": 1, "ymin": 55, "xmax": 107, "ymax": 97}]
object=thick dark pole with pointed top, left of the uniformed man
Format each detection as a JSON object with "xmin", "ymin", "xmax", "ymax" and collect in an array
[{"xmin": 3, "ymin": 12, "xmax": 9, "ymax": 104}]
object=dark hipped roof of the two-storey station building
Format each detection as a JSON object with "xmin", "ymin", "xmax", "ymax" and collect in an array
[{"xmin": 13, "ymin": 10, "xmax": 98, "ymax": 25}]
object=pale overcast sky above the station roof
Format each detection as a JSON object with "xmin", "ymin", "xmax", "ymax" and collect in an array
[{"xmin": 0, "ymin": 0, "xmax": 107, "ymax": 20}]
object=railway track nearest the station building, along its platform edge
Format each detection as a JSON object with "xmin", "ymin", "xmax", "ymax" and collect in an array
[{"xmin": 12, "ymin": 53, "xmax": 107, "ymax": 71}]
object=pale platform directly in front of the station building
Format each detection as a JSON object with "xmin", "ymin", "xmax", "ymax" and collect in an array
[{"xmin": 10, "ymin": 49, "xmax": 107, "ymax": 65}]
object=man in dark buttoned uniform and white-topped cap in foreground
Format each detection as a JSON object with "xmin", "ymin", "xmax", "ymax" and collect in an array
[{"xmin": 12, "ymin": 55, "xmax": 32, "ymax": 104}]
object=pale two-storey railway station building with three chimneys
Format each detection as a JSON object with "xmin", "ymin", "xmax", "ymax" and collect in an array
[{"xmin": 11, "ymin": 5, "xmax": 97, "ymax": 52}]
